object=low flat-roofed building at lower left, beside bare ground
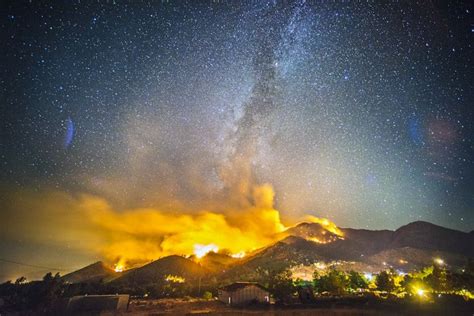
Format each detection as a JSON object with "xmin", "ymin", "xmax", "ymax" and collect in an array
[{"xmin": 66, "ymin": 294, "xmax": 130, "ymax": 315}]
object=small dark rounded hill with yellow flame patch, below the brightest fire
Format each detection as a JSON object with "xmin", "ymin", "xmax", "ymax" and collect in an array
[{"xmin": 112, "ymin": 255, "xmax": 208, "ymax": 286}]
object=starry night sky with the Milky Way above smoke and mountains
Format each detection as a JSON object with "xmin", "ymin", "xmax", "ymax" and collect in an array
[{"xmin": 0, "ymin": 0, "xmax": 474, "ymax": 278}]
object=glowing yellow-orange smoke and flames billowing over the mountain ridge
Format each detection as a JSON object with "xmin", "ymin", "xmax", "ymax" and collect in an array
[{"xmin": 2, "ymin": 184, "xmax": 342, "ymax": 273}]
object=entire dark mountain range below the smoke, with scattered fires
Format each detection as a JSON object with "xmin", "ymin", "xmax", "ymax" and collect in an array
[{"xmin": 64, "ymin": 221, "xmax": 474, "ymax": 286}]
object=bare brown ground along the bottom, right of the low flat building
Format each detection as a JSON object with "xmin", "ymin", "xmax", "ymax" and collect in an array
[{"xmin": 126, "ymin": 298, "xmax": 474, "ymax": 316}]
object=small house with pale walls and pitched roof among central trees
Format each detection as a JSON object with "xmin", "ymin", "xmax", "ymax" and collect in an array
[{"xmin": 218, "ymin": 282, "xmax": 270, "ymax": 305}]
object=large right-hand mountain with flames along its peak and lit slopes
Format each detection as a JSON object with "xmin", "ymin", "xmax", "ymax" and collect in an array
[{"xmin": 226, "ymin": 222, "xmax": 474, "ymax": 279}]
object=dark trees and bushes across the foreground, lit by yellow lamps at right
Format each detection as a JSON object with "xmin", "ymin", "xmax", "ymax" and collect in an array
[{"xmin": 0, "ymin": 261, "xmax": 474, "ymax": 313}]
